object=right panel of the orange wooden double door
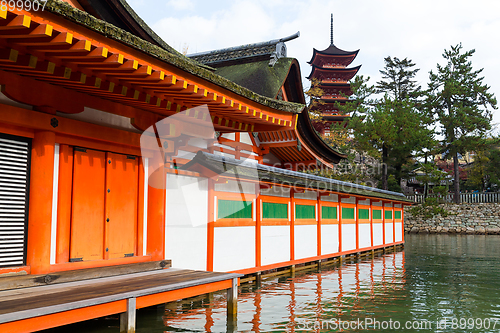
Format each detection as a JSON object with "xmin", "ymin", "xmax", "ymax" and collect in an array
[{"xmin": 106, "ymin": 153, "xmax": 139, "ymax": 259}]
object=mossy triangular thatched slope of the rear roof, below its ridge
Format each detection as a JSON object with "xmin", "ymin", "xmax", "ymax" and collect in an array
[{"xmin": 215, "ymin": 58, "xmax": 293, "ymax": 98}]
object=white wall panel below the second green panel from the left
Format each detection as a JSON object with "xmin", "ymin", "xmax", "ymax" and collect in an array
[{"xmin": 261, "ymin": 225, "xmax": 290, "ymax": 265}]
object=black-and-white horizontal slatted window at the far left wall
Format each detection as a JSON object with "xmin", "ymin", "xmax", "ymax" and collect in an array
[{"xmin": 0, "ymin": 134, "xmax": 31, "ymax": 267}]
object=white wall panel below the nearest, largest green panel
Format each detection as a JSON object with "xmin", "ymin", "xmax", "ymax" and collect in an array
[{"xmin": 214, "ymin": 226, "xmax": 255, "ymax": 272}]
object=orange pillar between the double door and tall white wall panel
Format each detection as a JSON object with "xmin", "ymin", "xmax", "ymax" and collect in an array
[{"xmin": 147, "ymin": 159, "xmax": 166, "ymax": 260}]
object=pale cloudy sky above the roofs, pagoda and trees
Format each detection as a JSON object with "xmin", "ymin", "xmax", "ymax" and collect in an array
[{"xmin": 128, "ymin": 0, "xmax": 500, "ymax": 133}]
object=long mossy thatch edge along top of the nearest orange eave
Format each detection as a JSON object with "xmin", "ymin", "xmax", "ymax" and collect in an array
[{"xmin": 41, "ymin": 0, "xmax": 305, "ymax": 113}]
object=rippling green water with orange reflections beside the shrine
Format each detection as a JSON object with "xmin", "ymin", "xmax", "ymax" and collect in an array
[{"xmin": 43, "ymin": 235, "xmax": 500, "ymax": 333}]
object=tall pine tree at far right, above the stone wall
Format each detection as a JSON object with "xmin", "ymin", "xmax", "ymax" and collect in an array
[{"xmin": 427, "ymin": 44, "xmax": 497, "ymax": 203}]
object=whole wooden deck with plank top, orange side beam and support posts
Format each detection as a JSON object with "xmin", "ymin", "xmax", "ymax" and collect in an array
[{"xmin": 0, "ymin": 268, "xmax": 242, "ymax": 332}]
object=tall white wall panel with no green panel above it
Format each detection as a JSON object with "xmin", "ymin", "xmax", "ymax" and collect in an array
[{"xmin": 165, "ymin": 174, "xmax": 208, "ymax": 270}]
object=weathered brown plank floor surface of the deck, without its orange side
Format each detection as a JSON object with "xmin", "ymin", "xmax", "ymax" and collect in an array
[{"xmin": 0, "ymin": 268, "xmax": 242, "ymax": 323}]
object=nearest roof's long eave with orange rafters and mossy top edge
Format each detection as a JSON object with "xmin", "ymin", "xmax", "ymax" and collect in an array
[{"xmin": 0, "ymin": 1, "xmax": 305, "ymax": 132}]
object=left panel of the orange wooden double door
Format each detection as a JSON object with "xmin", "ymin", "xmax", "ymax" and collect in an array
[{"xmin": 70, "ymin": 148, "xmax": 106, "ymax": 261}]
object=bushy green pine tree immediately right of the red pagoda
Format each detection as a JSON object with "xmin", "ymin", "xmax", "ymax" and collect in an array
[{"xmin": 346, "ymin": 57, "xmax": 433, "ymax": 191}]
